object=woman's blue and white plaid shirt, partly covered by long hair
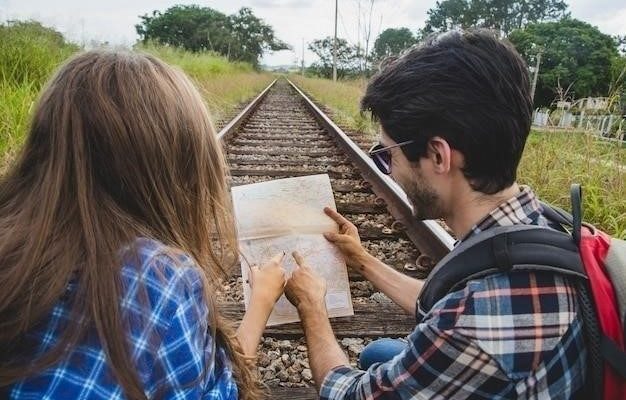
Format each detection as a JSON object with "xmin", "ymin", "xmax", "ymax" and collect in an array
[{"xmin": 8, "ymin": 239, "xmax": 238, "ymax": 400}]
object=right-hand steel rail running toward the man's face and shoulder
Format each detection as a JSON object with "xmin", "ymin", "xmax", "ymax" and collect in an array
[{"xmin": 287, "ymin": 79, "xmax": 454, "ymax": 262}]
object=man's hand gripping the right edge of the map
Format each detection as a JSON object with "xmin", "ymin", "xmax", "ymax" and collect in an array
[{"xmin": 324, "ymin": 207, "xmax": 369, "ymax": 269}]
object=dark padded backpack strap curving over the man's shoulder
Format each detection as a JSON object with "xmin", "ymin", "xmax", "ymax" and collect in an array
[{"xmin": 416, "ymin": 225, "xmax": 586, "ymax": 321}]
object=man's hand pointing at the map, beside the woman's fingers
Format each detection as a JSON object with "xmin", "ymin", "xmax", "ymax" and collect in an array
[{"xmin": 285, "ymin": 251, "xmax": 326, "ymax": 317}]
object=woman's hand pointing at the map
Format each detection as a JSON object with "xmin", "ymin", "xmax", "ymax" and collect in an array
[{"xmin": 249, "ymin": 252, "xmax": 285, "ymax": 315}]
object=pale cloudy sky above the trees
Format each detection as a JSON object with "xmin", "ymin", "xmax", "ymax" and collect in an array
[{"xmin": 0, "ymin": 0, "xmax": 626, "ymax": 65}]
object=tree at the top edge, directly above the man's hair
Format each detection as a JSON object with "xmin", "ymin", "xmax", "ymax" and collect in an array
[{"xmin": 424, "ymin": 0, "xmax": 569, "ymax": 36}]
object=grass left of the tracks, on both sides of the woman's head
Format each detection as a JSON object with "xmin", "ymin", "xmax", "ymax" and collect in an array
[{"xmin": 0, "ymin": 21, "xmax": 272, "ymax": 173}]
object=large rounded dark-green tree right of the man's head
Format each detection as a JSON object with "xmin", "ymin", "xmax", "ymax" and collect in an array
[{"xmin": 508, "ymin": 18, "xmax": 618, "ymax": 106}]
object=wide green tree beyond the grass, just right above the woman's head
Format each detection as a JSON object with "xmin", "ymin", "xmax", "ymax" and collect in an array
[{"xmin": 135, "ymin": 5, "xmax": 289, "ymax": 67}]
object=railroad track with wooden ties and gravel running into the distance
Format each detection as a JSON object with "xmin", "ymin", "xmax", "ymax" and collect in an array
[{"xmin": 218, "ymin": 79, "xmax": 452, "ymax": 400}]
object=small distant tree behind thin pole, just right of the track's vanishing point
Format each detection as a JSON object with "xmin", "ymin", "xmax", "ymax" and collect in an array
[{"xmin": 309, "ymin": 36, "xmax": 358, "ymax": 78}]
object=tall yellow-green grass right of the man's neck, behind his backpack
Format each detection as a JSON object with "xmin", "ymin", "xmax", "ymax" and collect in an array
[{"xmin": 519, "ymin": 132, "xmax": 626, "ymax": 239}]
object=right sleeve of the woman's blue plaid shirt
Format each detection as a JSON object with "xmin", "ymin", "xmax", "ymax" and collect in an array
[{"xmin": 124, "ymin": 252, "xmax": 237, "ymax": 399}]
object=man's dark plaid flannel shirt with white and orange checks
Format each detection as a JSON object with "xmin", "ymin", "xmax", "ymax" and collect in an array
[{"xmin": 320, "ymin": 187, "xmax": 586, "ymax": 399}]
